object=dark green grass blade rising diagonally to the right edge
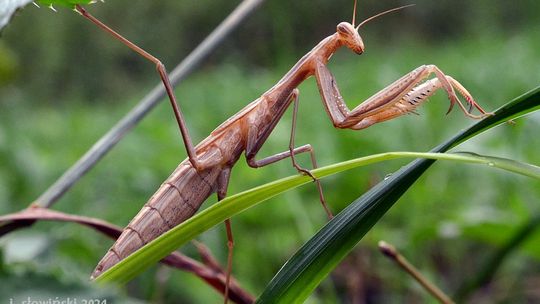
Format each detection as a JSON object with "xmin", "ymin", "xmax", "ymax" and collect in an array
[{"xmin": 257, "ymin": 87, "xmax": 540, "ymax": 303}]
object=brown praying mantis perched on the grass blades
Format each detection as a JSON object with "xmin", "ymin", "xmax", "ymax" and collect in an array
[{"xmin": 76, "ymin": 1, "xmax": 489, "ymax": 299}]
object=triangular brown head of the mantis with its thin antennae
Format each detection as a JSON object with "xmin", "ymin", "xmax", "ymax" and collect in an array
[{"xmin": 337, "ymin": 0, "xmax": 414, "ymax": 55}]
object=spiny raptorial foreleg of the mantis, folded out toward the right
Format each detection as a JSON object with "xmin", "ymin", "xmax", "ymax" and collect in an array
[{"xmin": 315, "ymin": 63, "xmax": 487, "ymax": 130}]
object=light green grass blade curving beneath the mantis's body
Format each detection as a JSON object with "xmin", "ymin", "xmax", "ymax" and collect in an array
[{"xmin": 96, "ymin": 152, "xmax": 540, "ymax": 283}]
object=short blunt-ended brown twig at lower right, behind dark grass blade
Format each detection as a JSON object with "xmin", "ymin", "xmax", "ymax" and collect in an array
[{"xmin": 379, "ymin": 241, "xmax": 454, "ymax": 304}]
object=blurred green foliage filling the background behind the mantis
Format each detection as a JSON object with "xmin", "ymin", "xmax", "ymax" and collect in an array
[{"xmin": 0, "ymin": 0, "xmax": 540, "ymax": 303}]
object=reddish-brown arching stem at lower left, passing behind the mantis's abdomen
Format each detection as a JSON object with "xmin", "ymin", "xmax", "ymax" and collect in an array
[{"xmin": 0, "ymin": 206, "xmax": 254, "ymax": 303}]
